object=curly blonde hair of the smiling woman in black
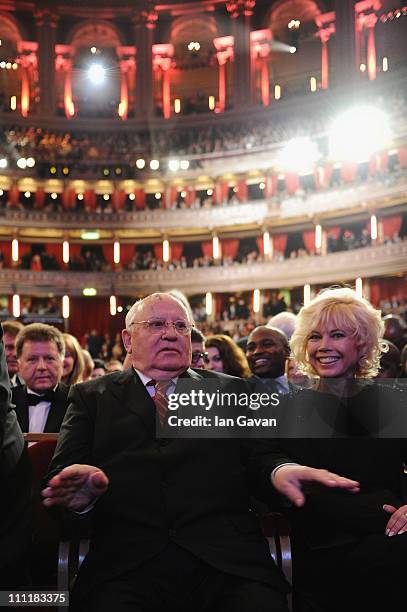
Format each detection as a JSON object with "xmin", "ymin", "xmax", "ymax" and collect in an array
[{"xmin": 290, "ymin": 287, "xmax": 386, "ymax": 378}]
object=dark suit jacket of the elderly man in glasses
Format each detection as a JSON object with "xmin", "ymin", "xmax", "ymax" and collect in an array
[{"xmin": 50, "ymin": 368, "xmax": 287, "ymax": 593}]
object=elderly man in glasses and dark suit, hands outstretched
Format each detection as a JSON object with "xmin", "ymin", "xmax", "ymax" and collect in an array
[{"xmin": 43, "ymin": 293, "xmax": 355, "ymax": 612}]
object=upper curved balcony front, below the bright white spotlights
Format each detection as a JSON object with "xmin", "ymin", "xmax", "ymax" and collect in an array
[{"xmin": 0, "ymin": 172, "xmax": 407, "ymax": 237}]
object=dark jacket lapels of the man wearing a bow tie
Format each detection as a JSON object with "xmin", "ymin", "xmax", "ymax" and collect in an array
[{"xmin": 11, "ymin": 383, "xmax": 69, "ymax": 433}]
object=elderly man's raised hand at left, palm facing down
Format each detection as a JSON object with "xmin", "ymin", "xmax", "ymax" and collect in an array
[{"xmin": 41, "ymin": 464, "xmax": 109, "ymax": 512}]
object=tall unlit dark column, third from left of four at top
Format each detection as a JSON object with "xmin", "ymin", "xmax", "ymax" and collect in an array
[{"xmin": 226, "ymin": 0, "xmax": 256, "ymax": 108}]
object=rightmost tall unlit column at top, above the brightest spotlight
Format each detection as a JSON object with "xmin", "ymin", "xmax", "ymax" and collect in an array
[{"xmin": 334, "ymin": 0, "xmax": 359, "ymax": 86}]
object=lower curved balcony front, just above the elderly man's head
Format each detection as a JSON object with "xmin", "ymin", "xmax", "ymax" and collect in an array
[{"xmin": 0, "ymin": 241, "xmax": 407, "ymax": 296}]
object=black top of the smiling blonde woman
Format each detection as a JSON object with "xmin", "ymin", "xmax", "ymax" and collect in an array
[{"xmin": 273, "ymin": 384, "xmax": 407, "ymax": 550}]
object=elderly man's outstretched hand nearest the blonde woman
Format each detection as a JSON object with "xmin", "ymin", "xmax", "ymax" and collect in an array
[{"xmin": 272, "ymin": 465, "xmax": 360, "ymax": 506}]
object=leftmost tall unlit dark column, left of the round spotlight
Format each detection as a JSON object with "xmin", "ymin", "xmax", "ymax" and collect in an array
[{"xmin": 34, "ymin": 6, "xmax": 58, "ymax": 115}]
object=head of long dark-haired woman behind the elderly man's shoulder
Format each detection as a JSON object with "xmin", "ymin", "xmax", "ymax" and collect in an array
[{"xmin": 205, "ymin": 334, "xmax": 251, "ymax": 378}]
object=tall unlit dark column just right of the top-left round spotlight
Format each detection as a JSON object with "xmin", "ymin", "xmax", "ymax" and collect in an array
[{"xmin": 133, "ymin": 0, "xmax": 158, "ymax": 118}]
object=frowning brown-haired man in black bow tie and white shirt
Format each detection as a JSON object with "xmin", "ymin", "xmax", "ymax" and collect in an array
[{"xmin": 12, "ymin": 323, "xmax": 69, "ymax": 433}]
